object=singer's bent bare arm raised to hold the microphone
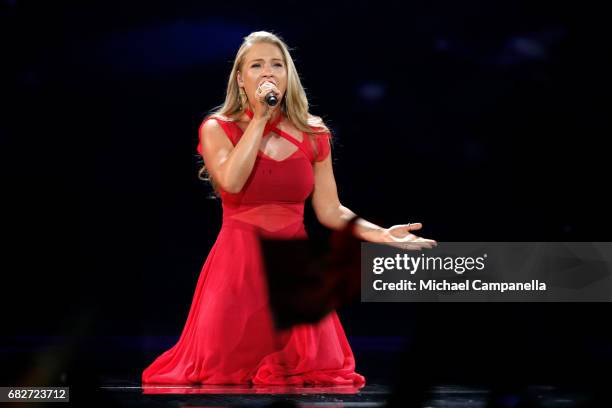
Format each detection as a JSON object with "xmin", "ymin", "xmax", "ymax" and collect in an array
[{"xmin": 200, "ymin": 118, "xmax": 266, "ymax": 193}]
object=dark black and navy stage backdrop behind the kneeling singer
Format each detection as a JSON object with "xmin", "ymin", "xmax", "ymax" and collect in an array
[{"xmin": 0, "ymin": 0, "xmax": 612, "ymax": 385}]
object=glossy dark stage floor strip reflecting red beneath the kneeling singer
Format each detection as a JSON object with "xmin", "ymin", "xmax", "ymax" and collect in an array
[{"xmin": 100, "ymin": 379, "xmax": 592, "ymax": 408}]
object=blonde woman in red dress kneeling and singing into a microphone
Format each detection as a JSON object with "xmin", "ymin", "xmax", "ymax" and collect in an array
[{"xmin": 142, "ymin": 31, "xmax": 436, "ymax": 386}]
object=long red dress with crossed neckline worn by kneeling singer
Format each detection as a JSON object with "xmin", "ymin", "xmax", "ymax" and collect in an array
[{"xmin": 142, "ymin": 111, "xmax": 365, "ymax": 387}]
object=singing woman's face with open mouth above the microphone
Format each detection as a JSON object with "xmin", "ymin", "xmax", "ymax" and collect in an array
[{"xmin": 237, "ymin": 43, "xmax": 287, "ymax": 109}]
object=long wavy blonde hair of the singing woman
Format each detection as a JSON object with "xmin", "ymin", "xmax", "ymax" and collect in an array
[{"xmin": 198, "ymin": 31, "xmax": 330, "ymax": 196}]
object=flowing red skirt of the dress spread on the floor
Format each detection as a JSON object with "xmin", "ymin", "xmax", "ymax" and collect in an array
[{"xmin": 142, "ymin": 222, "xmax": 365, "ymax": 387}]
